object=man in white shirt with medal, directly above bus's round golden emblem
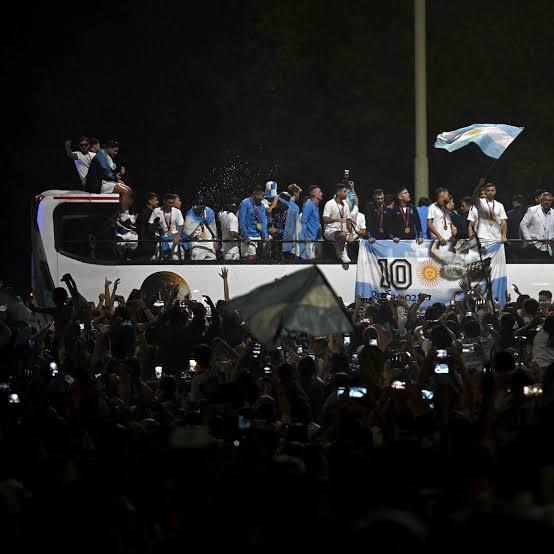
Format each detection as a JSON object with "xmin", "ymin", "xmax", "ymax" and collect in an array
[{"xmin": 148, "ymin": 192, "xmax": 185, "ymax": 260}]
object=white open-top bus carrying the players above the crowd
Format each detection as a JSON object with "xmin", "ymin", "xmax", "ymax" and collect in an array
[{"xmin": 32, "ymin": 190, "xmax": 554, "ymax": 304}]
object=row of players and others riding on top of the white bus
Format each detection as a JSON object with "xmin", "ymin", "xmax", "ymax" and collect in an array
[{"xmin": 66, "ymin": 137, "xmax": 554, "ymax": 263}]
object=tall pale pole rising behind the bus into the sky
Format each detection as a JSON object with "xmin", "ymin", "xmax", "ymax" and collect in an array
[{"xmin": 414, "ymin": 0, "xmax": 429, "ymax": 202}]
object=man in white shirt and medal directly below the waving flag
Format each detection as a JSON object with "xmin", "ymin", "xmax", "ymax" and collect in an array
[{"xmin": 467, "ymin": 183, "xmax": 508, "ymax": 242}]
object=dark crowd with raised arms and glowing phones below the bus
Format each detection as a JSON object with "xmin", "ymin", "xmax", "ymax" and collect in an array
[{"xmin": 0, "ymin": 262, "xmax": 554, "ymax": 554}]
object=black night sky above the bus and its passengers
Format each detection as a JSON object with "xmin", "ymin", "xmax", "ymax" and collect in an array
[{"xmin": 1, "ymin": 0, "xmax": 554, "ymax": 288}]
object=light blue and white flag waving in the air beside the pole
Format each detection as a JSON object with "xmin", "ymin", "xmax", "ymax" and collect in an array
[{"xmin": 434, "ymin": 123, "xmax": 524, "ymax": 158}]
